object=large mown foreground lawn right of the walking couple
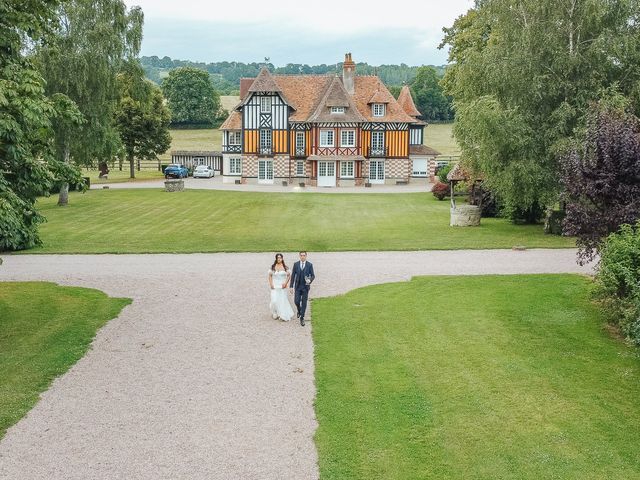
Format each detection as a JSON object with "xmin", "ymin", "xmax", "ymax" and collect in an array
[{"xmin": 313, "ymin": 275, "xmax": 640, "ymax": 480}]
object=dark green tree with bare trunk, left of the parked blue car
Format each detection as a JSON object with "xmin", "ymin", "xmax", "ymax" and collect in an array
[{"xmin": 115, "ymin": 60, "xmax": 171, "ymax": 178}]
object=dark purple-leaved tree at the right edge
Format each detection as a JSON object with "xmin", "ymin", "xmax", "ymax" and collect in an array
[{"xmin": 561, "ymin": 111, "xmax": 640, "ymax": 264}]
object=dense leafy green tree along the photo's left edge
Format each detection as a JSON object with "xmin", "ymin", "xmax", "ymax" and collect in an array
[{"xmin": 0, "ymin": 0, "xmax": 81, "ymax": 251}]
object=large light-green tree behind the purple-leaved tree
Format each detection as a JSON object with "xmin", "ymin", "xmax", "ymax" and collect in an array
[{"xmin": 442, "ymin": 0, "xmax": 640, "ymax": 220}]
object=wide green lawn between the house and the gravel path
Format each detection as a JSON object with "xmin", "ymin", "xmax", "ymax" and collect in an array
[{"xmin": 29, "ymin": 189, "xmax": 574, "ymax": 253}]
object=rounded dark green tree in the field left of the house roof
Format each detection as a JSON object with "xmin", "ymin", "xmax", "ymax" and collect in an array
[{"xmin": 162, "ymin": 67, "xmax": 222, "ymax": 126}]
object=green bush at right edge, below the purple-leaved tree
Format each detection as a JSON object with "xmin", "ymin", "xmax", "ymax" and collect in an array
[{"xmin": 594, "ymin": 221, "xmax": 640, "ymax": 345}]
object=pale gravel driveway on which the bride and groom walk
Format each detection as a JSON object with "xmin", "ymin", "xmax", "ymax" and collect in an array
[{"xmin": 0, "ymin": 250, "xmax": 590, "ymax": 480}]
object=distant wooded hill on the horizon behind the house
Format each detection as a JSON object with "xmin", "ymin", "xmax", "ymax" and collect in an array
[{"xmin": 140, "ymin": 55, "xmax": 445, "ymax": 95}]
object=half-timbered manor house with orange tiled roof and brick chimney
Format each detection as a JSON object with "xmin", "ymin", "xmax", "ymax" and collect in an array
[{"xmin": 220, "ymin": 54, "xmax": 437, "ymax": 187}]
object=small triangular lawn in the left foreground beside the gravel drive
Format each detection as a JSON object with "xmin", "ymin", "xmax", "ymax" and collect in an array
[{"xmin": 0, "ymin": 282, "xmax": 130, "ymax": 438}]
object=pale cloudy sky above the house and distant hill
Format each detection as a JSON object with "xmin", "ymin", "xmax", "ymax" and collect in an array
[{"xmin": 125, "ymin": 0, "xmax": 473, "ymax": 66}]
